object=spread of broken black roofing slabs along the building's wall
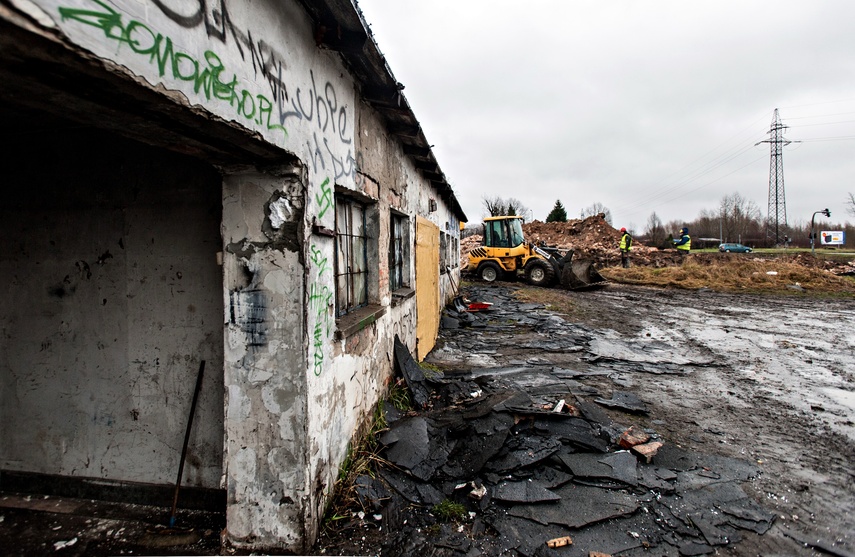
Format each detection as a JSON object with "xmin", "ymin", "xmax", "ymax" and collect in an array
[{"xmin": 318, "ymin": 287, "xmax": 775, "ymax": 557}]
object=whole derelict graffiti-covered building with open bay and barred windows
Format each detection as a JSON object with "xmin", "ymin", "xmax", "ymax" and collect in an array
[{"xmin": 0, "ymin": 0, "xmax": 465, "ymax": 551}]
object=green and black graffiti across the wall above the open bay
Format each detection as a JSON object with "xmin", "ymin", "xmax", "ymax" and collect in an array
[{"xmin": 59, "ymin": 0, "xmax": 360, "ymax": 183}]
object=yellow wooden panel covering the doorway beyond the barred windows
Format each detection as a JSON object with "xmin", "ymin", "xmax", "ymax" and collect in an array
[{"xmin": 416, "ymin": 217, "xmax": 440, "ymax": 361}]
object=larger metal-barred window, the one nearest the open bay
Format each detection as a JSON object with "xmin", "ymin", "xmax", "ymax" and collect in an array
[{"xmin": 335, "ymin": 196, "xmax": 368, "ymax": 316}]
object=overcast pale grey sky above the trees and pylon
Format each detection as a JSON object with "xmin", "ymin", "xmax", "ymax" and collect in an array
[{"xmin": 358, "ymin": 0, "xmax": 855, "ymax": 232}]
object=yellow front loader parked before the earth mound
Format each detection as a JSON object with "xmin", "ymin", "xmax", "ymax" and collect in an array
[{"xmin": 467, "ymin": 216, "xmax": 605, "ymax": 289}]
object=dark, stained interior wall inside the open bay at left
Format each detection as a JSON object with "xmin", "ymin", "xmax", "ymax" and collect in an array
[{"xmin": 0, "ymin": 126, "xmax": 223, "ymax": 488}]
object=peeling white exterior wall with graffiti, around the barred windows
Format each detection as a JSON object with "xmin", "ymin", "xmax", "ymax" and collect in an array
[{"xmin": 5, "ymin": 0, "xmax": 458, "ymax": 550}]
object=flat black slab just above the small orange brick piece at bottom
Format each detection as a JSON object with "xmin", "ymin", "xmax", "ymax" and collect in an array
[{"xmin": 508, "ymin": 484, "xmax": 638, "ymax": 528}]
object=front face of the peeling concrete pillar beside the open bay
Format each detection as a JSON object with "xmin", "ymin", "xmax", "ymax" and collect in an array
[{"xmin": 223, "ymin": 169, "xmax": 307, "ymax": 547}]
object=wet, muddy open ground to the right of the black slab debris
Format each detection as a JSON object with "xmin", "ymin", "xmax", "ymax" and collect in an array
[{"xmin": 437, "ymin": 284, "xmax": 855, "ymax": 556}]
